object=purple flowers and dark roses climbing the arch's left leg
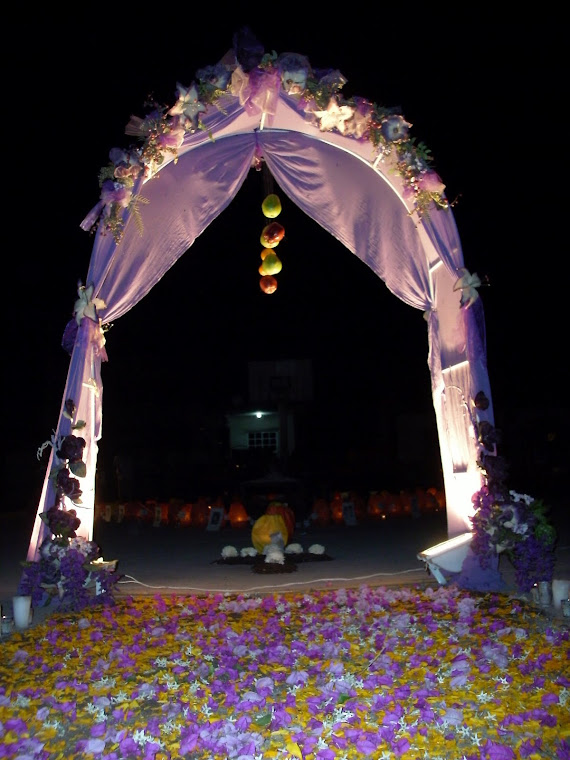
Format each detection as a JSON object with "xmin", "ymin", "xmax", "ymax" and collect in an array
[{"xmin": 18, "ymin": 399, "xmax": 120, "ymax": 612}]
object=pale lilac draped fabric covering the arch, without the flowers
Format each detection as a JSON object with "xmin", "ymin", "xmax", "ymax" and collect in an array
[{"xmin": 28, "ymin": 86, "xmax": 492, "ymax": 560}]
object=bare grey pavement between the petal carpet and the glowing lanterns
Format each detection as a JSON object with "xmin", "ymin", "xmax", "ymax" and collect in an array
[{"xmin": 0, "ymin": 514, "xmax": 570, "ymax": 623}]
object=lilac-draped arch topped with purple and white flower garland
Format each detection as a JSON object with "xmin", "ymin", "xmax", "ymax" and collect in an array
[{"xmin": 27, "ymin": 30, "xmax": 493, "ymax": 561}]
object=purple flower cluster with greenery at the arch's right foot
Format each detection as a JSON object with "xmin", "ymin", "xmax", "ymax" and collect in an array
[{"xmin": 458, "ymin": 393, "xmax": 557, "ymax": 593}]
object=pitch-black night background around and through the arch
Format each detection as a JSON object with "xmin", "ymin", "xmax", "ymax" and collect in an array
[{"xmin": 2, "ymin": 14, "xmax": 570, "ymax": 512}]
